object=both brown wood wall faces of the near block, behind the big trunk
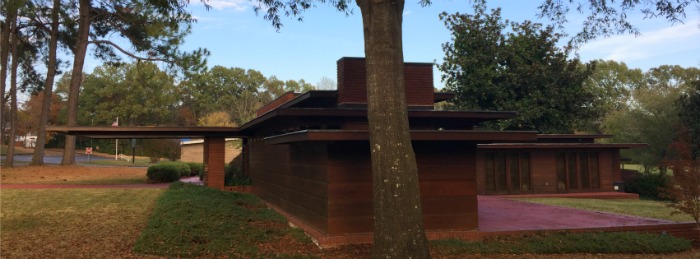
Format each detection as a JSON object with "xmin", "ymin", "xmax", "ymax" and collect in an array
[{"xmin": 250, "ymin": 141, "xmax": 478, "ymax": 239}]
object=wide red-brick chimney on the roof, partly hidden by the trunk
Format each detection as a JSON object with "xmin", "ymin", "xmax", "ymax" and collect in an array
[{"xmin": 338, "ymin": 58, "xmax": 435, "ymax": 108}]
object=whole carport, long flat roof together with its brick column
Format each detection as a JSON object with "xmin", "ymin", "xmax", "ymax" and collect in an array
[{"xmin": 46, "ymin": 126, "xmax": 242, "ymax": 190}]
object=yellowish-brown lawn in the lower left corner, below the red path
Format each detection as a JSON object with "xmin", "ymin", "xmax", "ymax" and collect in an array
[{"xmin": 0, "ymin": 188, "xmax": 163, "ymax": 258}]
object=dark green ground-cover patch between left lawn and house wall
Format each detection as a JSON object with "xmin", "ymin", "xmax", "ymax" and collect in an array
[{"xmin": 134, "ymin": 183, "xmax": 313, "ymax": 258}]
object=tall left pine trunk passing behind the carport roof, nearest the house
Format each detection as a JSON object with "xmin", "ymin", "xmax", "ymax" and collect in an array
[{"xmin": 61, "ymin": 0, "xmax": 91, "ymax": 165}]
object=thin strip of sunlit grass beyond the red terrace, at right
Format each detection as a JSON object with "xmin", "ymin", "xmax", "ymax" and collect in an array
[{"xmin": 515, "ymin": 198, "xmax": 693, "ymax": 222}]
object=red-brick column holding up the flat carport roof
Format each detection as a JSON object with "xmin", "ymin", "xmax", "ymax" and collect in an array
[{"xmin": 204, "ymin": 138, "xmax": 226, "ymax": 190}]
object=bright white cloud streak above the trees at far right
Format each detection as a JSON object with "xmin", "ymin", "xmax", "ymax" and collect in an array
[{"xmin": 579, "ymin": 19, "xmax": 700, "ymax": 65}]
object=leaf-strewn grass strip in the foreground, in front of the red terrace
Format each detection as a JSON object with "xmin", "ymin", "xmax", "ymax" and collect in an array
[{"xmin": 431, "ymin": 232, "xmax": 691, "ymax": 255}]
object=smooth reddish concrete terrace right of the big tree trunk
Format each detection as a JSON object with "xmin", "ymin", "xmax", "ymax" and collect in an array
[{"xmin": 478, "ymin": 196, "xmax": 674, "ymax": 232}]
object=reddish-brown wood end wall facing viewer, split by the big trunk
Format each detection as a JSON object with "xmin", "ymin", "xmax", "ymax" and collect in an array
[{"xmin": 328, "ymin": 142, "xmax": 478, "ymax": 235}]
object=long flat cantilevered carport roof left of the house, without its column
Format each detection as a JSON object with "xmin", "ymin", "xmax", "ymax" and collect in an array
[{"xmin": 46, "ymin": 126, "xmax": 243, "ymax": 139}]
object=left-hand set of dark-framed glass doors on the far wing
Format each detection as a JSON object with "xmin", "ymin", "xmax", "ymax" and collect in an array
[{"xmin": 484, "ymin": 152, "xmax": 530, "ymax": 193}]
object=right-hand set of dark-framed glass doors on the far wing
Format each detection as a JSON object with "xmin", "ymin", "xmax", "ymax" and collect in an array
[{"xmin": 556, "ymin": 152, "xmax": 600, "ymax": 192}]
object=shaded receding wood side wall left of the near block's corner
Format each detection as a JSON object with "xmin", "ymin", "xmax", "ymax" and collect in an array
[{"xmin": 249, "ymin": 139, "xmax": 328, "ymax": 233}]
